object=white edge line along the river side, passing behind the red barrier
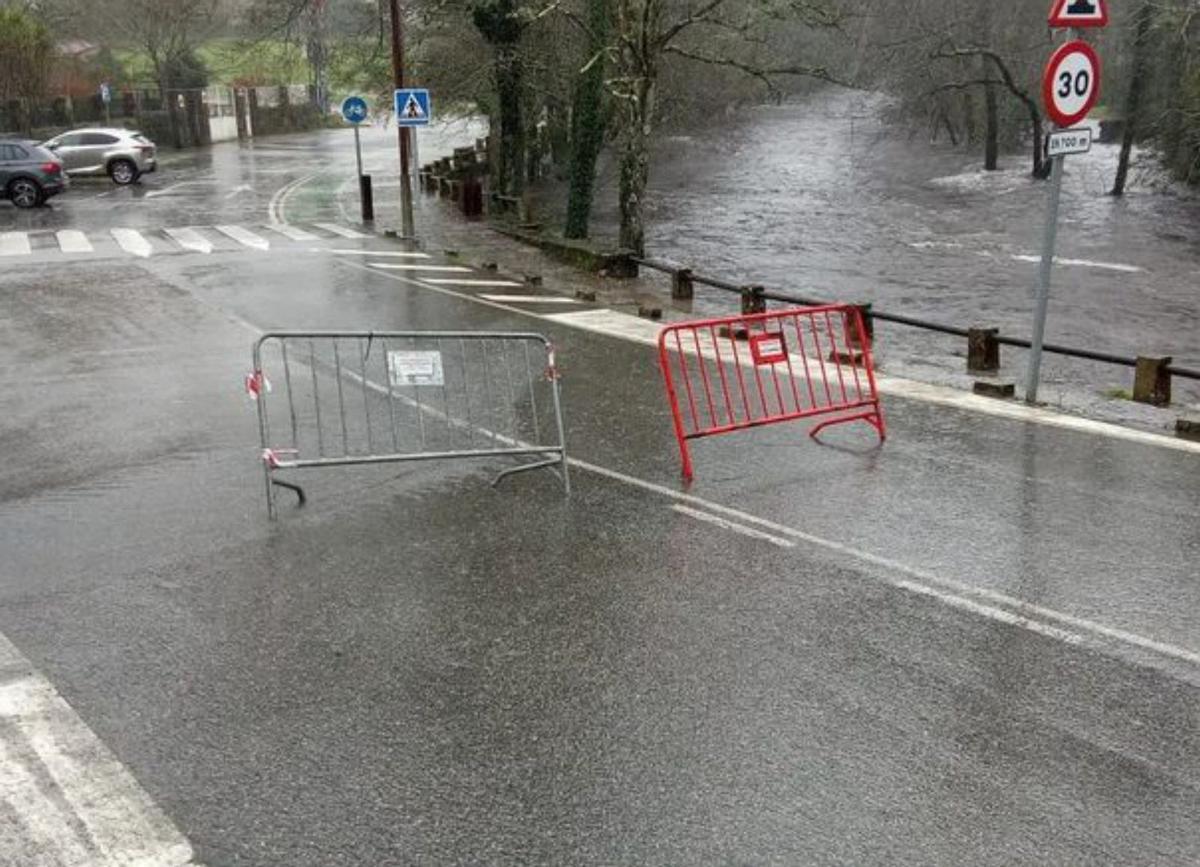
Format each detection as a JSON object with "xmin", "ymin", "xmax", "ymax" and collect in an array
[{"xmin": 343, "ymin": 262, "xmax": 1200, "ymax": 454}]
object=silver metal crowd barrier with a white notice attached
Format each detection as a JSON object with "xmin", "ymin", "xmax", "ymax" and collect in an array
[{"xmin": 246, "ymin": 331, "xmax": 570, "ymax": 520}]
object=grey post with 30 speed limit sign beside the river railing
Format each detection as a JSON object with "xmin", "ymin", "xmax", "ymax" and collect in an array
[{"xmin": 1025, "ymin": 16, "xmax": 1108, "ymax": 403}]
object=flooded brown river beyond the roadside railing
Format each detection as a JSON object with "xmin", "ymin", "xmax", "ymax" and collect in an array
[{"xmin": 588, "ymin": 92, "xmax": 1200, "ymax": 413}]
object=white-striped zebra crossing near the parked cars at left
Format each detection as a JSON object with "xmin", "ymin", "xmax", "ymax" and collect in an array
[{"xmin": 0, "ymin": 222, "xmax": 371, "ymax": 262}]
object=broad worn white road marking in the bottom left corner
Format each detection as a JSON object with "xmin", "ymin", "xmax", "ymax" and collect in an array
[{"xmin": 0, "ymin": 635, "xmax": 192, "ymax": 867}]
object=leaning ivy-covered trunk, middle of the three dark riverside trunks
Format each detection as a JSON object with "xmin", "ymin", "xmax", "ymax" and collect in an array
[{"xmin": 563, "ymin": 0, "xmax": 612, "ymax": 238}]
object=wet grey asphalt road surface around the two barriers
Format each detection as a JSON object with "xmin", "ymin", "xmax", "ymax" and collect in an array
[{"xmin": 0, "ymin": 130, "xmax": 1200, "ymax": 867}]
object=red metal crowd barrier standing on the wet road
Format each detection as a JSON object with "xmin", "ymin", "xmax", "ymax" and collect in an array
[{"xmin": 659, "ymin": 304, "xmax": 887, "ymax": 479}]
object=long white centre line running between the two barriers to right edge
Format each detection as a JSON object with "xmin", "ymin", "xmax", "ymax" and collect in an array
[{"xmin": 312, "ymin": 303, "xmax": 1200, "ymax": 669}]
